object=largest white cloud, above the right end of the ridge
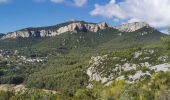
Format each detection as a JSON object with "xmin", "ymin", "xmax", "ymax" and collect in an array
[{"xmin": 90, "ymin": 0, "xmax": 170, "ymax": 28}]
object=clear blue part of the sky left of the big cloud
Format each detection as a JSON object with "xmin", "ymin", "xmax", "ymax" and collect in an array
[{"xmin": 0, "ymin": 0, "xmax": 114, "ymax": 32}]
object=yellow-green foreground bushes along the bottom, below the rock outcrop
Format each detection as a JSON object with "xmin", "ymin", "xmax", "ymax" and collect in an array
[{"xmin": 0, "ymin": 72, "xmax": 170, "ymax": 100}]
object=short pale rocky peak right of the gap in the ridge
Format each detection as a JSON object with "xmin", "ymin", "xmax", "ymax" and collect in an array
[{"xmin": 114, "ymin": 22, "xmax": 150, "ymax": 32}]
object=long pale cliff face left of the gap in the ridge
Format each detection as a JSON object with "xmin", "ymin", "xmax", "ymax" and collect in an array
[{"xmin": 2, "ymin": 22, "xmax": 108, "ymax": 39}]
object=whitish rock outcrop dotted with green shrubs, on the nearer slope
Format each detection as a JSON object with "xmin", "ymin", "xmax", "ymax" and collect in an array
[{"xmin": 86, "ymin": 49, "xmax": 170, "ymax": 87}]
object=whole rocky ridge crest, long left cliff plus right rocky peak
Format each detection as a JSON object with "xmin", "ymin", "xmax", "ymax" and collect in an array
[{"xmin": 1, "ymin": 21, "xmax": 153, "ymax": 39}]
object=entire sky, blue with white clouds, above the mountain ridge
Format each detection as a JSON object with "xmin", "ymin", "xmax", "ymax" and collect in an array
[{"xmin": 0, "ymin": 0, "xmax": 170, "ymax": 33}]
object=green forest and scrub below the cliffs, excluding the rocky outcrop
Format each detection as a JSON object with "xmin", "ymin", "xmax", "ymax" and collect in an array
[{"xmin": 0, "ymin": 26, "xmax": 170, "ymax": 100}]
